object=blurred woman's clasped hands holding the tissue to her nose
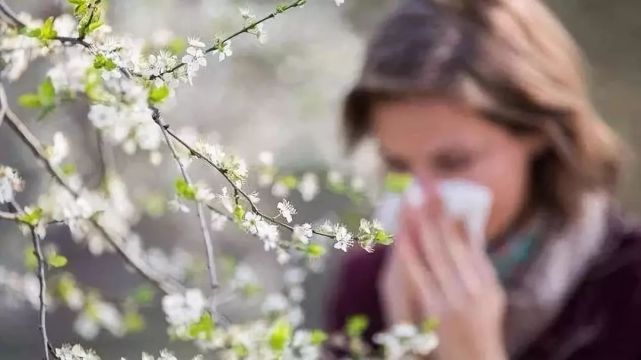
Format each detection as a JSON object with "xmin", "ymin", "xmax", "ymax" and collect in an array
[{"xmin": 382, "ymin": 184, "xmax": 507, "ymax": 360}]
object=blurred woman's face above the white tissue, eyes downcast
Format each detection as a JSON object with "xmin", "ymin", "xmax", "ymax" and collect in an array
[{"xmin": 373, "ymin": 99, "xmax": 539, "ymax": 239}]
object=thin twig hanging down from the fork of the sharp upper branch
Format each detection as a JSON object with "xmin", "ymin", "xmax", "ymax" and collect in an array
[{"xmin": 152, "ymin": 108, "xmax": 219, "ymax": 316}]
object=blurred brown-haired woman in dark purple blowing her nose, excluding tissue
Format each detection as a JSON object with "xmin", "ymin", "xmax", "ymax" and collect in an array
[{"xmin": 330, "ymin": 0, "xmax": 641, "ymax": 360}]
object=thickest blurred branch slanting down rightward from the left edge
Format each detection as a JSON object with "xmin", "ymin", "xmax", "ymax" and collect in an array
[{"xmin": 0, "ymin": 85, "xmax": 182, "ymax": 293}]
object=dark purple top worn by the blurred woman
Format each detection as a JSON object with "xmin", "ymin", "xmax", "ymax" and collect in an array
[{"xmin": 328, "ymin": 212, "xmax": 641, "ymax": 360}]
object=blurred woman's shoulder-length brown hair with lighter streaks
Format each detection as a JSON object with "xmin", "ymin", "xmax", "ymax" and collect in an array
[{"xmin": 344, "ymin": 0, "xmax": 620, "ymax": 223}]
